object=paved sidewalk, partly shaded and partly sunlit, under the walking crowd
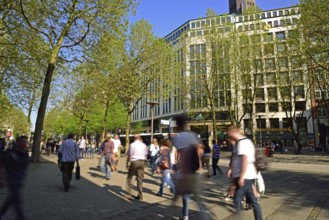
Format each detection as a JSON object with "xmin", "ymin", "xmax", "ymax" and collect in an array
[{"xmin": 0, "ymin": 155, "xmax": 329, "ymax": 220}]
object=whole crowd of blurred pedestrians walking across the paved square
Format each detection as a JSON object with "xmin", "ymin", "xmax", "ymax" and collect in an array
[{"xmin": 0, "ymin": 116, "xmax": 263, "ymax": 220}]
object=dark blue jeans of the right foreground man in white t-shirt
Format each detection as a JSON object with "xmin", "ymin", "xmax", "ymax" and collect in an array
[{"xmin": 233, "ymin": 178, "xmax": 263, "ymax": 220}]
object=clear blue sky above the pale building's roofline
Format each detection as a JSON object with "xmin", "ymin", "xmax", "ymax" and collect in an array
[{"xmin": 130, "ymin": 0, "xmax": 299, "ymax": 37}]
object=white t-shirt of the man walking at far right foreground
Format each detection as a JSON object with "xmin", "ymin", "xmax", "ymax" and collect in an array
[{"xmin": 238, "ymin": 139, "xmax": 257, "ymax": 179}]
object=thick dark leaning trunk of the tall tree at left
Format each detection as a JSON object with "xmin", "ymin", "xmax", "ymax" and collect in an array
[{"xmin": 31, "ymin": 62, "xmax": 56, "ymax": 162}]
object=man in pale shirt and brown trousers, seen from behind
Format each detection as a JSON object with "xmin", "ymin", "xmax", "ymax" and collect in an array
[{"xmin": 126, "ymin": 135, "xmax": 147, "ymax": 200}]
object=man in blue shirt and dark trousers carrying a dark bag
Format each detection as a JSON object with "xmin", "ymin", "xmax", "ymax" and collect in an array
[{"xmin": 58, "ymin": 134, "xmax": 79, "ymax": 192}]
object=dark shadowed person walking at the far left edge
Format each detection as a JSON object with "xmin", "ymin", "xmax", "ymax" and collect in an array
[{"xmin": 0, "ymin": 136, "xmax": 29, "ymax": 220}]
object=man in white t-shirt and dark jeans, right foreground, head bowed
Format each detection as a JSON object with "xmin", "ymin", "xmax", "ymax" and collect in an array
[{"xmin": 227, "ymin": 125, "xmax": 263, "ymax": 220}]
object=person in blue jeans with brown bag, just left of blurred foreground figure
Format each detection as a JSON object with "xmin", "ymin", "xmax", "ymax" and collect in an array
[{"xmin": 157, "ymin": 138, "xmax": 175, "ymax": 197}]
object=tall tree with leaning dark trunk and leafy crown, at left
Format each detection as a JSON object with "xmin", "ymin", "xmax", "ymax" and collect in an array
[{"xmin": 2, "ymin": 0, "xmax": 134, "ymax": 161}]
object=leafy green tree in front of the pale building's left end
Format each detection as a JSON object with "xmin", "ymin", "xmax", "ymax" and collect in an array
[{"xmin": 112, "ymin": 20, "xmax": 175, "ymax": 151}]
